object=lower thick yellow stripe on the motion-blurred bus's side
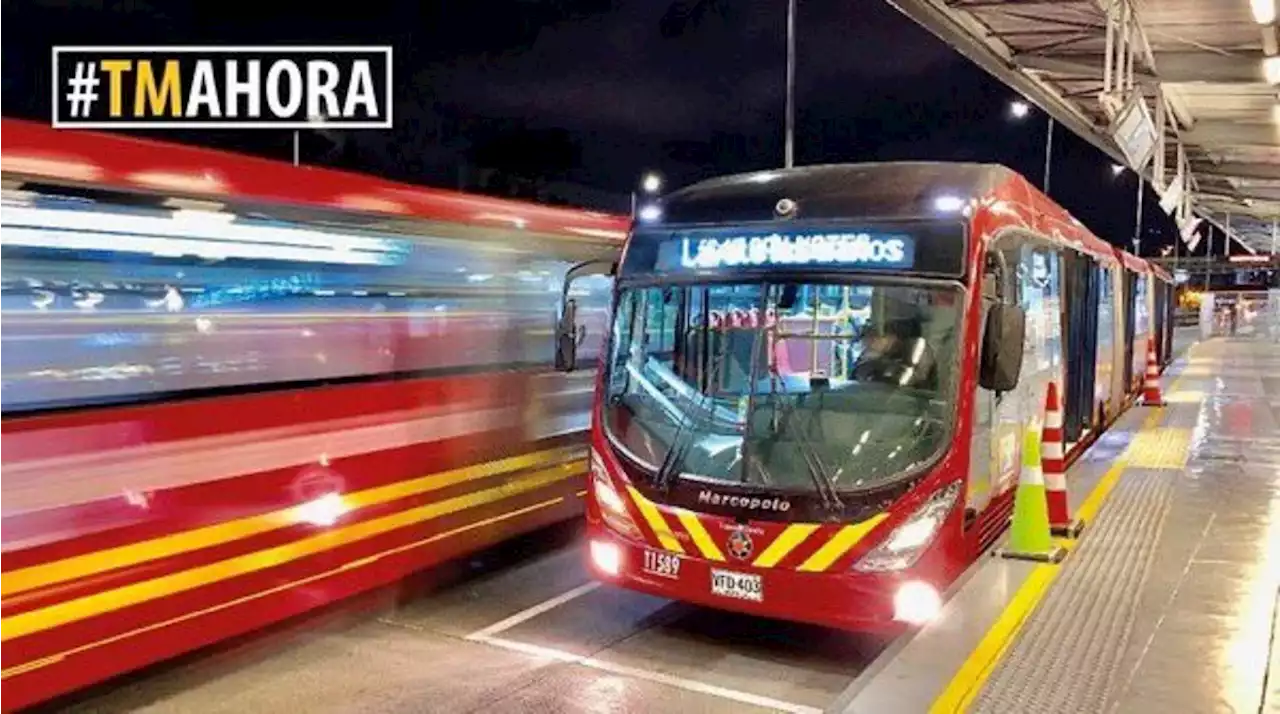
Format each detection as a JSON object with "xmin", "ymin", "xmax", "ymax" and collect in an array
[{"xmin": 0, "ymin": 459, "xmax": 586, "ymax": 641}]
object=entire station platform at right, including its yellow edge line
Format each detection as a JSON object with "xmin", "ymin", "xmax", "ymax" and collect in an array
[{"xmin": 829, "ymin": 338, "xmax": 1280, "ymax": 714}]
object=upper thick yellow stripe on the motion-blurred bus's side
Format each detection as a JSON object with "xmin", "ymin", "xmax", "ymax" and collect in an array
[{"xmin": 0, "ymin": 447, "xmax": 584, "ymax": 596}]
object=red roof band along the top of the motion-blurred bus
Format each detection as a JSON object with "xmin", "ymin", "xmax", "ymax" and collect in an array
[{"xmin": 0, "ymin": 119, "xmax": 628, "ymax": 244}]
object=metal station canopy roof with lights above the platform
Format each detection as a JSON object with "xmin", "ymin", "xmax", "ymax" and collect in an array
[{"xmin": 886, "ymin": 0, "xmax": 1280, "ymax": 252}]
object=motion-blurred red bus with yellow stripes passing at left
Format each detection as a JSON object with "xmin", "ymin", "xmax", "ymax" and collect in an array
[{"xmin": 0, "ymin": 119, "xmax": 627, "ymax": 710}]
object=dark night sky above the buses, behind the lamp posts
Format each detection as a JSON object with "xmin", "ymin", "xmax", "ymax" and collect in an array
[{"xmin": 0, "ymin": 0, "xmax": 1177, "ymax": 255}]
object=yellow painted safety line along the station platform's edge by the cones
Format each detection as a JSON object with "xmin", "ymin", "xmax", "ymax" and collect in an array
[{"xmin": 929, "ymin": 365, "xmax": 1183, "ymax": 714}]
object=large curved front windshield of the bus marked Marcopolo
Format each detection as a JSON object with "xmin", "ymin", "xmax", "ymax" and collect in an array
[{"xmin": 604, "ymin": 282, "xmax": 963, "ymax": 493}]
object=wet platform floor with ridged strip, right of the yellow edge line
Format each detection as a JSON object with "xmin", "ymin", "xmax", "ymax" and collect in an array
[{"xmin": 972, "ymin": 338, "xmax": 1280, "ymax": 714}]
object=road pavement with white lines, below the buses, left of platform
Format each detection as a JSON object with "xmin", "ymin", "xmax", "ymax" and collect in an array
[{"xmin": 46, "ymin": 525, "xmax": 884, "ymax": 714}]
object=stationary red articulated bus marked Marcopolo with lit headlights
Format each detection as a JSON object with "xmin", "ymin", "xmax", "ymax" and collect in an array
[{"xmin": 557, "ymin": 163, "xmax": 1172, "ymax": 632}]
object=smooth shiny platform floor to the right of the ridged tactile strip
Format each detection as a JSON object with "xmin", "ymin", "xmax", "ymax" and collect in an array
[{"xmin": 1108, "ymin": 339, "xmax": 1280, "ymax": 713}]
